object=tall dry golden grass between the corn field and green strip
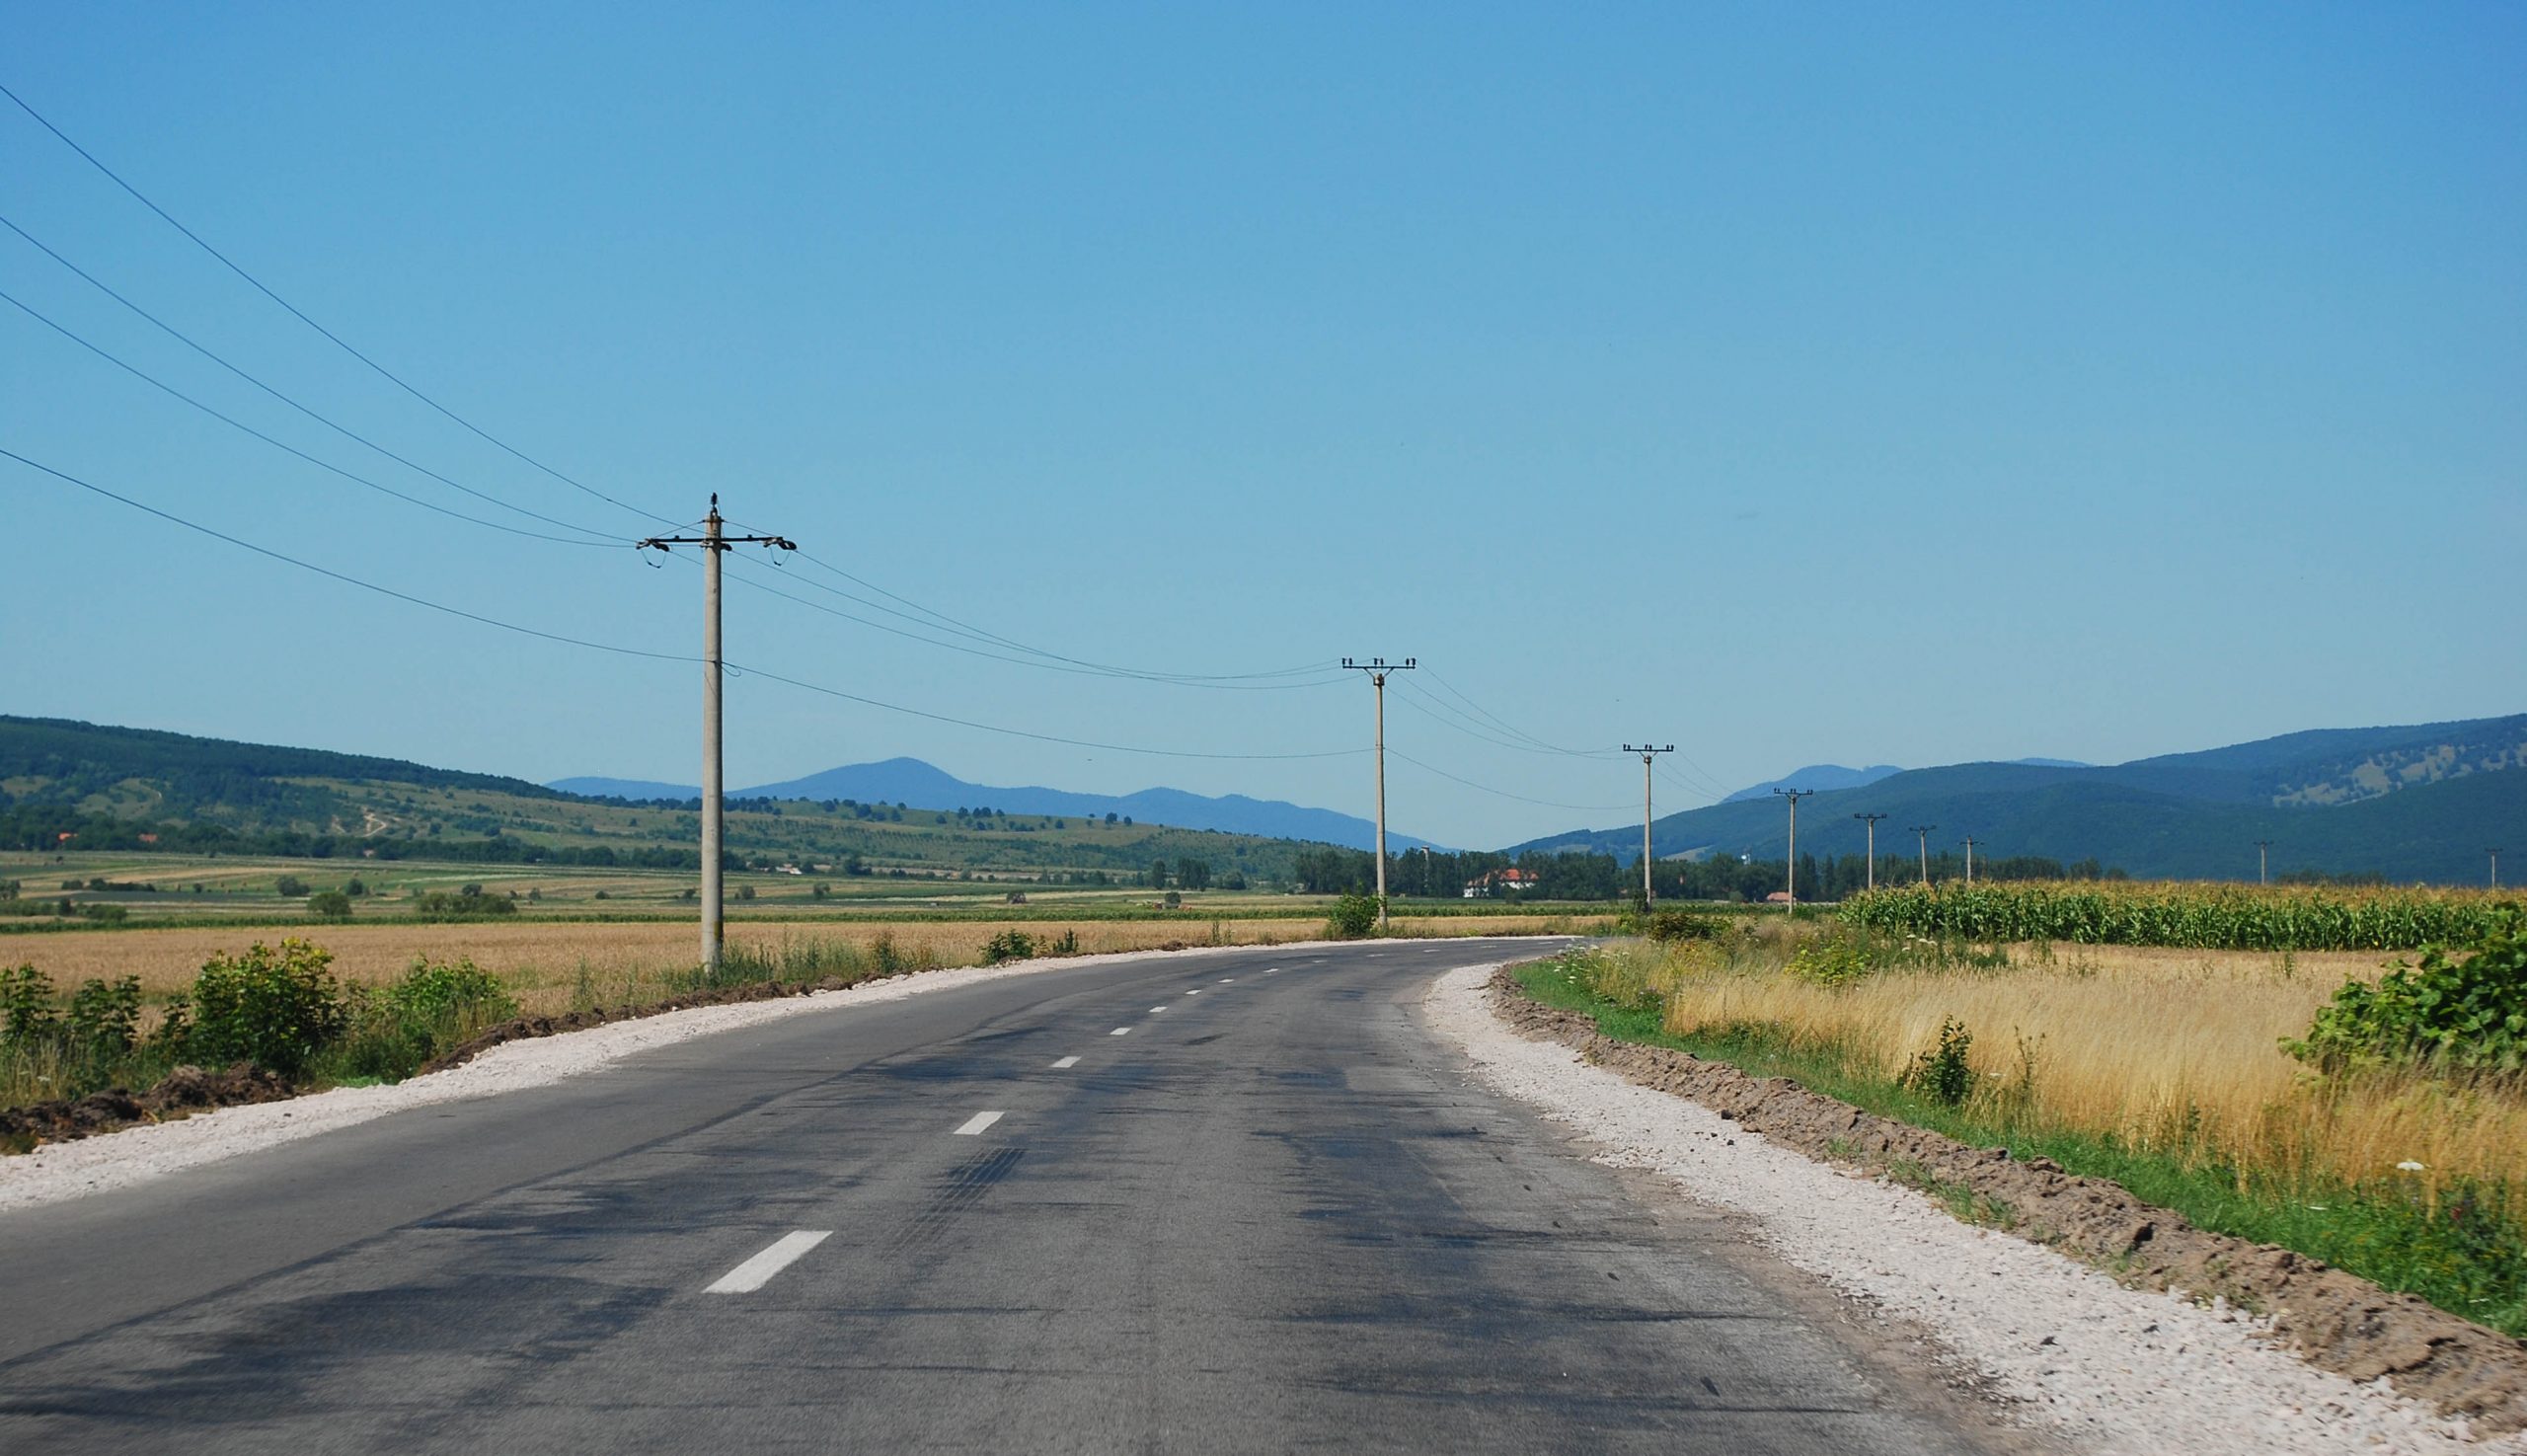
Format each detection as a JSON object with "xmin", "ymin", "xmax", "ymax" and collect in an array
[{"xmin": 1625, "ymin": 925, "xmax": 2527, "ymax": 1193}]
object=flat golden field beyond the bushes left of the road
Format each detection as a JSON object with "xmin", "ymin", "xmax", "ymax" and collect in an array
[{"xmin": 0, "ymin": 915, "xmax": 1571, "ymax": 1014}]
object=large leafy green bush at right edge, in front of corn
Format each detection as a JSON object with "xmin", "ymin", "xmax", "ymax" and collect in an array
[{"xmin": 2282, "ymin": 918, "xmax": 2527, "ymax": 1077}]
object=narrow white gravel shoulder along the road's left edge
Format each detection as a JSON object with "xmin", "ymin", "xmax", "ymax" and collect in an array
[{"xmin": 0, "ymin": 943, "xmax": 1307, "ymax": 1213}]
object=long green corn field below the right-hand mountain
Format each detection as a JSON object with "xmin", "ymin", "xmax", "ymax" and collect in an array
[{"xmin": 1840, "ymin": 882, "xmax": 2519, "ymax": 951}]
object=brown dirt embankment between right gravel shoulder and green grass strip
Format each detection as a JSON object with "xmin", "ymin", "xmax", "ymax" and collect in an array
[{"xmin": 1491, "ymin": 968, "xmax": 2527, "ymax": 1433}]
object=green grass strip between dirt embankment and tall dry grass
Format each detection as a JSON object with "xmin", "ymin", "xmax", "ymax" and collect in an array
[{"xmin": 1513, "ymin": 956, "xmax": 2527, "ymax": 1338}]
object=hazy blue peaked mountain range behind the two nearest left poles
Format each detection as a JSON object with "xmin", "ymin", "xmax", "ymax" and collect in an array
[{"xmin": 546, "ymin": 758, "xmax": 1440, "ymax": 852}]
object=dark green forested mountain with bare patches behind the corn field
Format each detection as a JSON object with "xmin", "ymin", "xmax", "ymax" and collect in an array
[{"xmin": 1516, "ymin": 713, "xmax": 2527, "ymax": 884}]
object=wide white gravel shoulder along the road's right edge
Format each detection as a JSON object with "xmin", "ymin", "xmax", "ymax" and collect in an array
[{"xmin": 1425, "ymin": 968, "xmax": 2527, "ymax": 1456}]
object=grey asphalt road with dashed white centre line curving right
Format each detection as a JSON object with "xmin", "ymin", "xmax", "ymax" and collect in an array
[{"xmin": 0, "ymin": 943, "xmax": 2017, "ymax": 1456}]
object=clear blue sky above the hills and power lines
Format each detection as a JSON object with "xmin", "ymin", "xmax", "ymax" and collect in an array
[{"xmin": 0, "ymin": 0, "xmax": 2527, "ymax": 844}]
